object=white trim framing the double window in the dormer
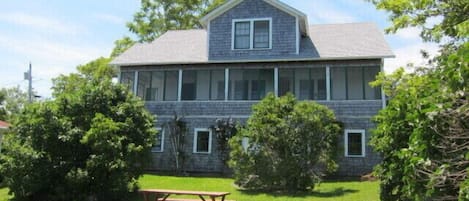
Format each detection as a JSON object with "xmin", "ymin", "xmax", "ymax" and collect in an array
[{"xmin": 231, "ymin": 18, "xmax": 272, "ymax": 50}]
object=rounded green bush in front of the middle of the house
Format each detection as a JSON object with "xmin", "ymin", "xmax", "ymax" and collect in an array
[{"xmin": 229, "ymin": 94, "xmax": 342, "ymax": 190}]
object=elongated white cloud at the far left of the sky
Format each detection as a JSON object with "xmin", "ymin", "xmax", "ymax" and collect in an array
[{"xmin": 0, "ymin": 12, "xmax": 85, "ymax": 35}]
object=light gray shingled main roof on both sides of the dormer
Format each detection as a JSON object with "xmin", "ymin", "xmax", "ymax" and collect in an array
[{"xmin": 111, "ymin": 23, "xmax": 394, "ymax": 66}]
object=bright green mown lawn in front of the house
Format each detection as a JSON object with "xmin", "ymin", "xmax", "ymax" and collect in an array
[{"xmin": 0, "ymin": 175, "xmax": 379, "ymax": 201}]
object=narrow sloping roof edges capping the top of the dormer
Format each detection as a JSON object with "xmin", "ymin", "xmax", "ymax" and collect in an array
[{"xmin": 200, "ymin": 0, "xmax": 308, "ymax": 35}]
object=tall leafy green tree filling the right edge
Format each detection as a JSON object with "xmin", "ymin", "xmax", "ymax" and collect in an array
[{"xmin": 370, "ymin": 0, "xmax": 469, "ymax": 201}]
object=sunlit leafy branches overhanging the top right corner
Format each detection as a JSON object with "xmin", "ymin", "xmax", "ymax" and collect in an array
[{"xmin": 368, "ymin": 0, "xmax": 469, "ymax": 43}]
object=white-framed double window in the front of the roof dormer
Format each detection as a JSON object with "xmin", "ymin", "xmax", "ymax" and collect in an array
[{"xmin": 232, "ymin": 18, "xmax": 272, "ymax": 50}]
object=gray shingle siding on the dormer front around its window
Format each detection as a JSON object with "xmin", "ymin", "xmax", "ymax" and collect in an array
[{"xmin": 209, "ymin": 0, "xmax": 296, "ymax": 61}]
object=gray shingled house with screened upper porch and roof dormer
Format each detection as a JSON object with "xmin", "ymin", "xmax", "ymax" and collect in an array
[{"xmin": 112, "ymin": 0, "xmax": 393, "ymax": 175}]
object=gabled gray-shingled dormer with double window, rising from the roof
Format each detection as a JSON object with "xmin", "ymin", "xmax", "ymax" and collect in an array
[{"xmin": 201, "ymin": 0, "xmax": 308, "ymax": 62}]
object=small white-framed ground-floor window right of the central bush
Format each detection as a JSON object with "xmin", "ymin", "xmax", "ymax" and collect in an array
[{"xmin": 344, "ymin": 129, "xmax": 365, "ymax": 157}]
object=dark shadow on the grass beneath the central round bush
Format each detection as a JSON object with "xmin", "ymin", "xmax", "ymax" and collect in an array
[{"xmin": 238, "ymin": 187, "xmax": 359, "ymax": 198}]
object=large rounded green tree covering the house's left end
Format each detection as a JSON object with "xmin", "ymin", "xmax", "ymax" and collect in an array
[{"xmin": 0, "ymin": 59, "xmax": 156, "ymax": 201}]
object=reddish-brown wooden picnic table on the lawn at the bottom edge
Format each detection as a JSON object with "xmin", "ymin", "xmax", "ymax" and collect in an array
[{"xmin": 139, "ymin": 189, "xmax": 234, "ymax": 201}]
